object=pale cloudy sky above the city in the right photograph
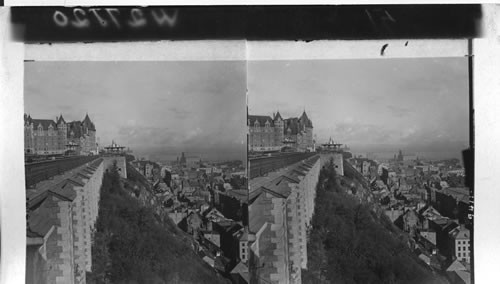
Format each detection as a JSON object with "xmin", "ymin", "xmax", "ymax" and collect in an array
[{"xmin": 248, "ymin": 57, "xmax": 469, "ymax": 160}]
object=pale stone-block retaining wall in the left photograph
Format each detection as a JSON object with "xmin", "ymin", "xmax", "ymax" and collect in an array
[{"xmin": 26, "ymin": 159, "xmax": 104, "ymax": 283}]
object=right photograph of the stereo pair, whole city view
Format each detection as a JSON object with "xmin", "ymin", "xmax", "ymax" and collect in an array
[{"xmin": 247, "ymin": 57, "xmax": 473, "ymax": 283}]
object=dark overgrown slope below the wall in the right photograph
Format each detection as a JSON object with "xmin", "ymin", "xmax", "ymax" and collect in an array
[{"xmin": 302, "ymin": 161, "xmax": 447, "ymax": 284}]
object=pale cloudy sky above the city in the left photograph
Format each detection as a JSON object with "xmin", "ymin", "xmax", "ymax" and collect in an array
[{"xmin": 24, "ymin": 61, "xmax": 246, "ymax": 162}]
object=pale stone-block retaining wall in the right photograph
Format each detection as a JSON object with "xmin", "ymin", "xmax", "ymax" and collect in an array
[{"xmin": 250, "ymin": 155, "xmax": 320, "ymax": 283}]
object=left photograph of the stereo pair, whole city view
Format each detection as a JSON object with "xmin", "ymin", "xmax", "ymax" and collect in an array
[{"xmin": 24, "ymin": 60, "xmax": 248, "ymax": 283}]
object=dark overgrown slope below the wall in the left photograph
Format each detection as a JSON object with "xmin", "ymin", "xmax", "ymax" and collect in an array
[{"xmin": 87, "ymin": 164, "xmax": 228, "ymax": 283}]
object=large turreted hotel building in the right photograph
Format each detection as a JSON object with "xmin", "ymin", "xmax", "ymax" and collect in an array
[{"xmin": 247, "ymin": 111, "xmax": 314, "ymax": 151}]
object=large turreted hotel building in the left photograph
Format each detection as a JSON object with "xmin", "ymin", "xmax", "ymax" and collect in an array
[{"xmin": 24, "ymin": 114, "xmax": 97, "ymax": 155}]
